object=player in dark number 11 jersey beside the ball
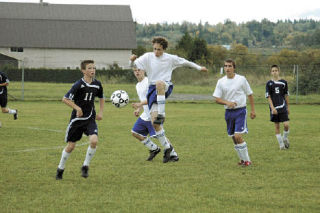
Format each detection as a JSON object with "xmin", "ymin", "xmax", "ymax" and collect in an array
[{"xmin": 56, "ymin": 60, "xmax": 104, "ymax": 180}]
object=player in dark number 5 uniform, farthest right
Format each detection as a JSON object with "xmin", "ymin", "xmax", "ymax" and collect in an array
[{"xmin": 266, "ymin": 65, "xmax": 290, "ymax": 150}]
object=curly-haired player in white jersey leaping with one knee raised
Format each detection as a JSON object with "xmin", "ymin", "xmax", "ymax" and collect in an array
[{"xmin": 130, "ymin": 37, "xmax": 208, "ymax": 163}]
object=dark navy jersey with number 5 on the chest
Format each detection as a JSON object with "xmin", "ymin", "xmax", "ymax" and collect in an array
[{"xmin": 266, "ymin": 79, "xmax": 289, "ymax": 113}]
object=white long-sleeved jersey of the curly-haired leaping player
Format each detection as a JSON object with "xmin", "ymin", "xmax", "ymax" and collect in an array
[{"xmin": 134, "ymin": 52, "xmax": 201, "ymax": 84}]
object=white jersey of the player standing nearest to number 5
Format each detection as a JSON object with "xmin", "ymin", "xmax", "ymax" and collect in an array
[{"xmin": 213, "ymin": 74, "xmax": 253, "ymax": 109}]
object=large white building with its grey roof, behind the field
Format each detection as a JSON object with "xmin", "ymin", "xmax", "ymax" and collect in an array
[{"xmin": 0, "ymin": 2, "xmax": 137, "ymax": 69}]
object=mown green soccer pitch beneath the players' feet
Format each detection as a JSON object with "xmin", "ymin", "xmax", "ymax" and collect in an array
[{"xmin": 0, "ymin": 101, "xmax": 320, "ymax": 212}]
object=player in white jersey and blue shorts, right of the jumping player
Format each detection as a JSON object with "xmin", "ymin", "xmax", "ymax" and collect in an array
[{"xmin": 213, "ymin": 59, "xmax": 256, "ymax": 166}]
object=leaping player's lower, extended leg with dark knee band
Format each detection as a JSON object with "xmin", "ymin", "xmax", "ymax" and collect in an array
[{"xmin": 151, "ymin": 110, "xmax": 173, "ymax": 163}]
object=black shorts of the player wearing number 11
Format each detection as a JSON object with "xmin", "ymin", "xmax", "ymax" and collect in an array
[{"xmin": 65, "ymin": 118, "xmax": 98, "ymax": 142}]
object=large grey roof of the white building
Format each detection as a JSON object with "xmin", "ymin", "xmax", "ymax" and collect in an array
[{"xmin": 0, "ymin": 2, "xmax": 136, "ymax": 49}]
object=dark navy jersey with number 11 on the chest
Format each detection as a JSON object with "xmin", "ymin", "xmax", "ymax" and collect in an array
[{"xmin": 64, "ymin": 78, "xmax": 103, "ymax": 119}]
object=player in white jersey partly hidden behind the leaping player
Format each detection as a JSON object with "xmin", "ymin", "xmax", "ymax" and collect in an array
[{"xmin": 131, "ymin": 68, "xmax": 179, "ymax": 161}]
